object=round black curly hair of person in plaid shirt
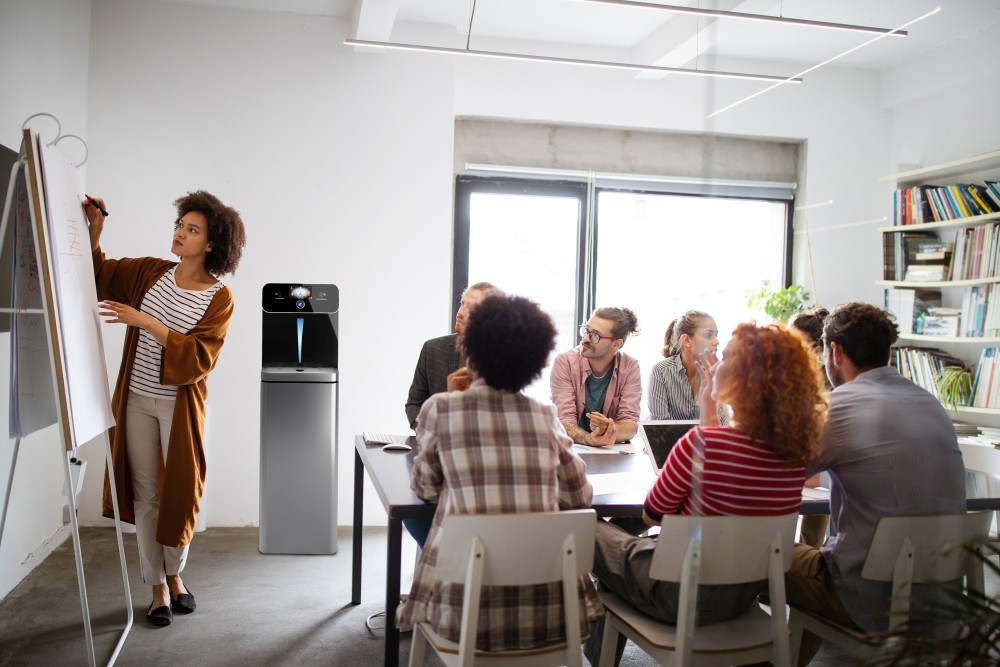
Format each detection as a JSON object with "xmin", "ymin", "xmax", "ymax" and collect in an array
[{"xmin": 461, "ymin": 296, "xmax": 556, "ymax": 392}]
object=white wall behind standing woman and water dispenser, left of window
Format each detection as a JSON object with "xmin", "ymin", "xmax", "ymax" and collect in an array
[{"xmin": 74, "ymin": 0, "xmax": 453, "ymax": 536}]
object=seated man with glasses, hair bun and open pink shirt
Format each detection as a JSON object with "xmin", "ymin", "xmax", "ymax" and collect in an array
[{"xmin": 550, "ymin": 308, "xmax": 642, "ymax": 447}]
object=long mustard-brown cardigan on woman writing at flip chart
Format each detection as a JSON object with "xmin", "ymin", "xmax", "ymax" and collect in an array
[{"xmin": 93, "ymin": 248, "xmax": 233, "ymax": 547}]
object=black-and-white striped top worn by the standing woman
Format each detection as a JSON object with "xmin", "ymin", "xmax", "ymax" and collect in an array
[{"xmin": 128, "ymin": 266, "xmax": 222, "ymax": 398}]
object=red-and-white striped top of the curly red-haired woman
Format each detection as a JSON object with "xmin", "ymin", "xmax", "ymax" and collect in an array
[{"xmin": 645, "ymin": 426, "xmax": 806, "ymax": 520}]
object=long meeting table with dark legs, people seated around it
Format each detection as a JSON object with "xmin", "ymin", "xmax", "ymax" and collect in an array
[{"xmin": 351, "ymin": 435, "xmax": 1000, "ymax": 667}]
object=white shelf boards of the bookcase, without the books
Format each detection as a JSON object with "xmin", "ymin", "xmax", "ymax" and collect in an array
[{"xmin": 877, "ymin": 150, "xmax": 1000, "ymax": 428}]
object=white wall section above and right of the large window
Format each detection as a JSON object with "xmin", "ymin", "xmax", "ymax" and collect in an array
[{"xmin": 455, "ymin": 59, "xmax": 890, "ymax": 308}]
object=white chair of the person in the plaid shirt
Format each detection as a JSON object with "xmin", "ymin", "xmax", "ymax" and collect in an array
[{"xmin": 410, "ymin": 510, "xmax": 597, "ymax": 667}]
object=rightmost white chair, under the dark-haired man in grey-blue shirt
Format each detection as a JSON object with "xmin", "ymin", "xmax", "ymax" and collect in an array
[{"xmin": 788, "ymin": 511, "xmax": 993, "ymax": 664}]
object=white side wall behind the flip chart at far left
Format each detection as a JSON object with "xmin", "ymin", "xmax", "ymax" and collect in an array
[{"xmin": 0, "ymin": 0, "xmax": 90, "ymax": 598}]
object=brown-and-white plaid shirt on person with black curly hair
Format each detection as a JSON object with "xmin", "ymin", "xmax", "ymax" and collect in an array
[{"xmin": 396, "ymin": 380, "xmax": 604, "ymax": 650}]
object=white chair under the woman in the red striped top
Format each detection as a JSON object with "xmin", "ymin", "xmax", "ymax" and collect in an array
[{"xmin": 600, "ymin": 514, "xmax": 798, "ymax": 667}]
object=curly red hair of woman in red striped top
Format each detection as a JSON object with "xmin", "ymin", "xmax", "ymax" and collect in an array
[{"xmin": 716, "ymin": 324, "xmax": 826, "ymax": 464}]
